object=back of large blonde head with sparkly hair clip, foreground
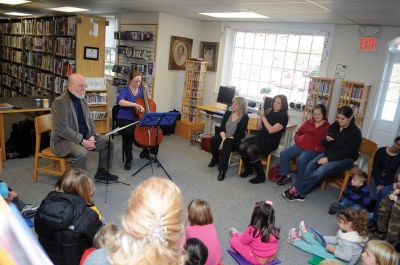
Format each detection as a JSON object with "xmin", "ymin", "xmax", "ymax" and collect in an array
[{"xmin": 109, "ymin": 177, "xmax": 183, "ymax": 265}]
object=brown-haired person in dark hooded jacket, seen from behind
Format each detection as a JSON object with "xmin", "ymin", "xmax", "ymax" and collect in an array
[{"xmin": 35, "ymin": 169, "xmax": 103, "ymax": 265}]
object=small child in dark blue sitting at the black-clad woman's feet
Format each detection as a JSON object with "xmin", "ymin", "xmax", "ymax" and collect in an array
[{"xmin": 329, "ymin": 167, "xmax": 371, "ymax": 215}]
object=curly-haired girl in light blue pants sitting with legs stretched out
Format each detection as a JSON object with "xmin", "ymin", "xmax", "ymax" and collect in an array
[{"xmin": 288, "ymin": 208, "xmax": 368, "ymax": 265}]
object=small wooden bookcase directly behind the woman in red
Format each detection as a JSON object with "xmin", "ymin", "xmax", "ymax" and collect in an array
[{"xmin": 303, "ymin": 76, "xmax": 335, "ymax": 121}]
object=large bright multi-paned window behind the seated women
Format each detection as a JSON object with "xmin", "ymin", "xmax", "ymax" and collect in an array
[{"xmin": 229, "ymin": 32, "xmax": 325, "ymax": 102}]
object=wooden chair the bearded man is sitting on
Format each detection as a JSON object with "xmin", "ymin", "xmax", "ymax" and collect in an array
[{"xmin": 32, "ymin": 114, "xmax": 70, "ymax": 182}]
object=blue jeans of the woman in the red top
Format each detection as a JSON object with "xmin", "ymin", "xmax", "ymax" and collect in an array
[{"xmin": 279, "ymin": 144, "xmax": 319, "ymax": 179}]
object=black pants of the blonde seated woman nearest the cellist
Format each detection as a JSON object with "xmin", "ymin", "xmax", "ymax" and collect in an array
[{"xmin": 211, "ymin": 134, "xmax": 240, "ymax": 170}]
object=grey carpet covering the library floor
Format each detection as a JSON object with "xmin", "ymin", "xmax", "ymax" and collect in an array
[{"xmin": 1, "ymin": 135, "xmax": 344, "ymax": 265}]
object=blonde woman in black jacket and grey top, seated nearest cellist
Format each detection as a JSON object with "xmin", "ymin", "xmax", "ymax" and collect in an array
[{"xmin": 208, "ymin": 97, "xmax": 249, "ymax": 181}]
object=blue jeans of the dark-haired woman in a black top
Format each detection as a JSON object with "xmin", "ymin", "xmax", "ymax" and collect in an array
[{"xmin": 294, "ymin": 153, "xmax": 354, "ymax": 195}]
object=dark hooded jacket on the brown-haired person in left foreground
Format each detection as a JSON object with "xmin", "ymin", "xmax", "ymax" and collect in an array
[{"xmin": 35, "ymin": 191, "xmax": 102, "ymax": 265}]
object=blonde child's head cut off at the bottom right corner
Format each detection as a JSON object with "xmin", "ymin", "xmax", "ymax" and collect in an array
[{"xmin": 362, "ymin": 240, "xmax": 399, "ymax": 265}]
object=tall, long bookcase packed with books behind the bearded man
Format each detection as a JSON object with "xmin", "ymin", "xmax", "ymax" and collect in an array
[{"xmin": 0, "ymin": 15, "xmax": 109, "ymax": 133}]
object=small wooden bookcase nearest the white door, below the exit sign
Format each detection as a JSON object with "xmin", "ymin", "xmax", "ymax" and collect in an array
[{"xmin": 337, "ymin": 80, "xmax": 371, "ymax": 128}]
